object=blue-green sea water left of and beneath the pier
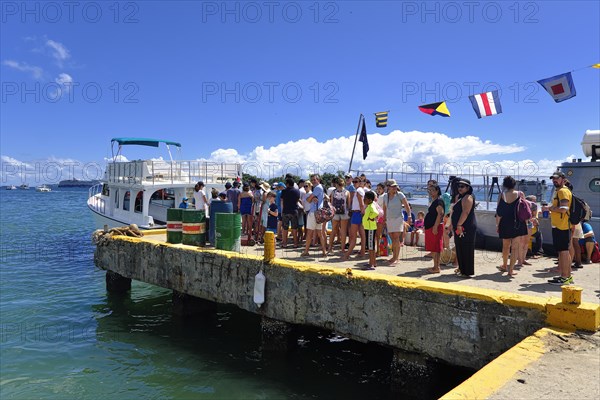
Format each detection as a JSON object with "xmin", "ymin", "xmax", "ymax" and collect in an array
[{"xmin": 0, "ymin": 188, "xmax": 468, "ymax": 400}]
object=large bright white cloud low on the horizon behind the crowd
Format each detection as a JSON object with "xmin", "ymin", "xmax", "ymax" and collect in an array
[{"xmin": 200, "ymin": 130, "xmax": 567, "ymax": 178}]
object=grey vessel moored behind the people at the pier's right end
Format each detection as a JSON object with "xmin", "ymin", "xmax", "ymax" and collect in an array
[{"xmin": 409, "ymin": 130, "xmax": 600, "ymax": 250}]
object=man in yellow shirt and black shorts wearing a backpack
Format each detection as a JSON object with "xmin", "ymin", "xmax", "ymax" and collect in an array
[{"xmin": 543, "ymin": 171, "xmax": 574, "ymax": 286}]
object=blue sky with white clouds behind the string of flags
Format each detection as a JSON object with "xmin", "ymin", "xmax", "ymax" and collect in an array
[{"xmin": 0, "ymin": 1, "xmax": 600, "ymax": 183}]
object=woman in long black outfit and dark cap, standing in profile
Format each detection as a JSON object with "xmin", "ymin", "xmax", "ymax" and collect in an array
[{"xmin": 452, "ymin": 179, "xmax": 477, "ymax": 278}]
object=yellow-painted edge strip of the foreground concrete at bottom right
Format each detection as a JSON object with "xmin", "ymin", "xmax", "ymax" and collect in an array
[{"xmin": 440, "ymin": 328, "xmax": 568, "ymax": 400}]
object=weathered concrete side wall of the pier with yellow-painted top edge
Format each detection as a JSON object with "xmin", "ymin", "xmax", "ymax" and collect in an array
[{"xmin": 95, "ymin": 231, "xmax": 600, "ymax": 369}]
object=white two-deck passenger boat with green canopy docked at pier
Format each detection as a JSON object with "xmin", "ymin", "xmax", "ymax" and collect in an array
[{"xmin": 87, "ymin": 138, "xmax": 242, "ymax": 229}]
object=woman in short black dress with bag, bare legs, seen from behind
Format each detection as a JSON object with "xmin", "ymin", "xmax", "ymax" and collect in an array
[{"xmin": 496, "ymin": 176, "xmax": 527, "ymax": 277}]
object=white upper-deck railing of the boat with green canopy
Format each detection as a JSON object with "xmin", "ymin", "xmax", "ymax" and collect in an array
[{"xmin": 106, "ymin": 160, "xmax": 242, "ymax": 185}]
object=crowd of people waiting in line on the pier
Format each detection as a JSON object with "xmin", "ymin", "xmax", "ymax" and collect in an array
[{"xmin": 180, "ymin": 172, "xmax": 595, "ymax": 285}]
